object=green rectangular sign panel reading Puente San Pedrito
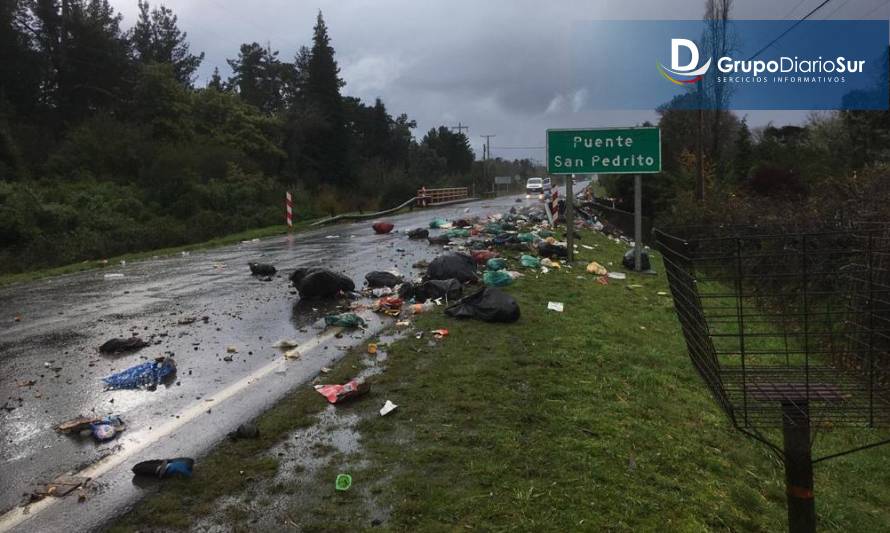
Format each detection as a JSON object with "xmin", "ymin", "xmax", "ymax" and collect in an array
[{"xmin": 547, "ymin": 128, "xmax": 661, "ymax": 174}]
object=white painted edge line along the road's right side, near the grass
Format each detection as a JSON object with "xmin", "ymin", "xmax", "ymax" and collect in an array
[{"xmin": 0, "ymin": 328, "xmax": 343, "ymax": 532}]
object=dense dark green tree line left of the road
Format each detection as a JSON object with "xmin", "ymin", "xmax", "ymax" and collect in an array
[{"xmin": 0, "ymin": 0, "xmax": 536, "ymax": 271}]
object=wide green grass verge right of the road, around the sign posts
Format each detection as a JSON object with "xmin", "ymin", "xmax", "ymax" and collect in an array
[{"xmin": 107, "ymin": 233, "xmax": 890, "ymax": 531}]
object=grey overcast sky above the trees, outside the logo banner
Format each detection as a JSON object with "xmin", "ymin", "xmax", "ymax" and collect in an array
[{"xmin": 111, "ymin": 0, "xmax": 890, "ymax": 160}]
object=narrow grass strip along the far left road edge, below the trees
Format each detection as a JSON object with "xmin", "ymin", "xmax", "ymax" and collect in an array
[{"xmin": 0, "ymin": 220, "xmax": 312, "ymax": 287}]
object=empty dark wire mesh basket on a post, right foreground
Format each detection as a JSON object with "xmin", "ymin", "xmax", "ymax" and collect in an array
[{"xmin": 655, "ymin": 226, "xmax": 890, "ymax": 428}]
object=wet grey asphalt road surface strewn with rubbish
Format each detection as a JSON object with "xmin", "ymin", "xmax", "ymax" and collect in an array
[{"xmin": 0, "ymin": 191, "xmax": 556, "ymax": 531}]
